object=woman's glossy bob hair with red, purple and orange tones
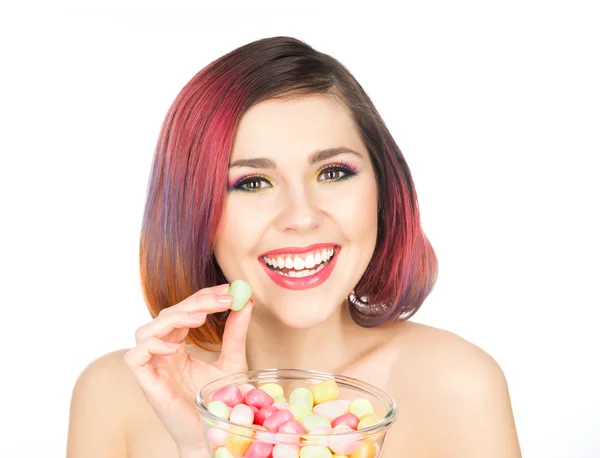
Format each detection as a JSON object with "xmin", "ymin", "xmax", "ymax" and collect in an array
[{"xmin": 140, "ymin": 37, "xmax": 437, "ymax": 349}]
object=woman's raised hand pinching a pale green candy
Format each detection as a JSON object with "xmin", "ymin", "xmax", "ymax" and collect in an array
[{"xmin": 125, "ymin": 284, "xmax": 253, "ymax": 456}]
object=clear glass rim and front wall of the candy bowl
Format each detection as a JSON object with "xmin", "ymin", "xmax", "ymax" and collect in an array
[{"xmin": 196, "ymin": 369, "xmax": 397, "ymax": 458}]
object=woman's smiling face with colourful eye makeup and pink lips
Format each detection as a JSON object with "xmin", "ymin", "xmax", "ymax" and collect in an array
[{"xmin": 213, "ymin": 95, "xmax": 377, "ymax": 328}]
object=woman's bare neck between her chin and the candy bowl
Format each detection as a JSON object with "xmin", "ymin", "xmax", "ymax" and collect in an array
[{"xmin": 246, "ymin": 306, "xmax": 364, "ymax": 372}]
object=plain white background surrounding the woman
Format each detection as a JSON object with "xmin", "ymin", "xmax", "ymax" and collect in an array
[{"xmin": 0, "ymin": 0, "xmax": 600, "ymax": 458}]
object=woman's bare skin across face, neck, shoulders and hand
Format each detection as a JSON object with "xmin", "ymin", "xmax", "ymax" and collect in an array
[{"xmin": 67, "ymin": 95, "xmax": 521, "ymax": 458}]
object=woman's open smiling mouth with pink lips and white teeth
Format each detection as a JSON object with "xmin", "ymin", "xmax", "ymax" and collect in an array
[{"xmin": 259, "ymin": 243, "xmax": 340, "ymax": 289}]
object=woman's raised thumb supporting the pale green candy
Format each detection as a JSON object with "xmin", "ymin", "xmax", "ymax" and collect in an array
[{"xmin": 216, "ymin": 299, "xmax": 254, "ymax": 374}]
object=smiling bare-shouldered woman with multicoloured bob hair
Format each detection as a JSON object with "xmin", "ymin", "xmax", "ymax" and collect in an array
[{"xmin": 68, "ymin": 37, "xmax": 520, "ymax": 458}]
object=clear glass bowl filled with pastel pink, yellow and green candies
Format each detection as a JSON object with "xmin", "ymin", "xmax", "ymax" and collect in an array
[{"xmin": 196, "ymin": 369, "xmax": 397, "ymax": 458}]
